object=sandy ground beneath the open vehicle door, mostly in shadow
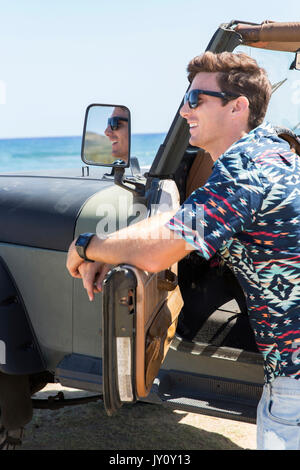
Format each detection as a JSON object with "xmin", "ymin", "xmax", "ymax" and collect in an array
[{"xmin": 20, "ymin": 384, "xmax": 256, "ymax": 450}]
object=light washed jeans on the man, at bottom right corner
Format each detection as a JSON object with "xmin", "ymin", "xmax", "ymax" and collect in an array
[{"xmin": 256, "ymin": 377, "xmax": 300, "ymax": 450}]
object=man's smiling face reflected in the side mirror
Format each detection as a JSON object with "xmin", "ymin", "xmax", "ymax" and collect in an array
[{"xmin": 104, "ymin": 106, "xmax": 129, "ymax": 163}]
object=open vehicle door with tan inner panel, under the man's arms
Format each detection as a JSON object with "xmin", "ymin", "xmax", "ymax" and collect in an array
[{"xmin": 102, "ymin": 180, "xmax": 183, "ymax": 415}]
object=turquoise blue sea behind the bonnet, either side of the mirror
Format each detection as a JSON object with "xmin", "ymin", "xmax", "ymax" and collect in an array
[{"xmin": 0, "ymin": 133, "xmax": 166, "ymax": 173}]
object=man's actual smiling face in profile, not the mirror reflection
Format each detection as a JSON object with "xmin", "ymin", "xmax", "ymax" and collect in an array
[{"xmin": 180, "ymin": 72, "xmax": 231, "ymax": 152}]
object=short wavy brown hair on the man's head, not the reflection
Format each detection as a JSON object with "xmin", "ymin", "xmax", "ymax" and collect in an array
[{"xmin": 187, "ymin": 51, "xmax": 272, "ymax": 129}]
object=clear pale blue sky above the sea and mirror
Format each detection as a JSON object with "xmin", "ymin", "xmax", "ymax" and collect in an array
[{"xmin": 0, "ymin": 0, "xmax": 300, "ymax": 138}]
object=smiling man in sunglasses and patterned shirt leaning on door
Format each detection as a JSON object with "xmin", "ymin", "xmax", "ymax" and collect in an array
[{"xmin": 67, "ymin": 52, "xmax": 300, "ymax": 449}]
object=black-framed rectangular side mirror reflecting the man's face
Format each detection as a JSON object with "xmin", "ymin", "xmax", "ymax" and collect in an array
[{"xmin": 81, "ymin": 104, "xmax": 131, "ymax": 168}]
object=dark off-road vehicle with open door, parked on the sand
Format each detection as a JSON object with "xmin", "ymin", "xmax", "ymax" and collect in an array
[{"xmin": 0, "ymin": 21, "xmax": 300, "ymax": 446}]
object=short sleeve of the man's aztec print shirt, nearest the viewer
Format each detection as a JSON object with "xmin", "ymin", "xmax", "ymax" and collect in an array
[{"xmin": 166, "ymin": 154, "xmax": 264, "ymax": 260}]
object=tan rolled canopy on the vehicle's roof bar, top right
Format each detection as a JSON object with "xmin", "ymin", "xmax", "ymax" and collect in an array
[{"xmin": 234, "ymin": 21, "xmax": 300, "ymax": 52}]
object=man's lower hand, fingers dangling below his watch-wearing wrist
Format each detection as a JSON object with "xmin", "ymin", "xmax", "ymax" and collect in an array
[{"xmin": 78, "ymin": 262, "xmax": 112, "ymax": 301}]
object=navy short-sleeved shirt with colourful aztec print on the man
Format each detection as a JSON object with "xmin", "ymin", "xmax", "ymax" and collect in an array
[{"xmin": 167, "ymin": 123, "xmax": 300, "ymax": 382}]
